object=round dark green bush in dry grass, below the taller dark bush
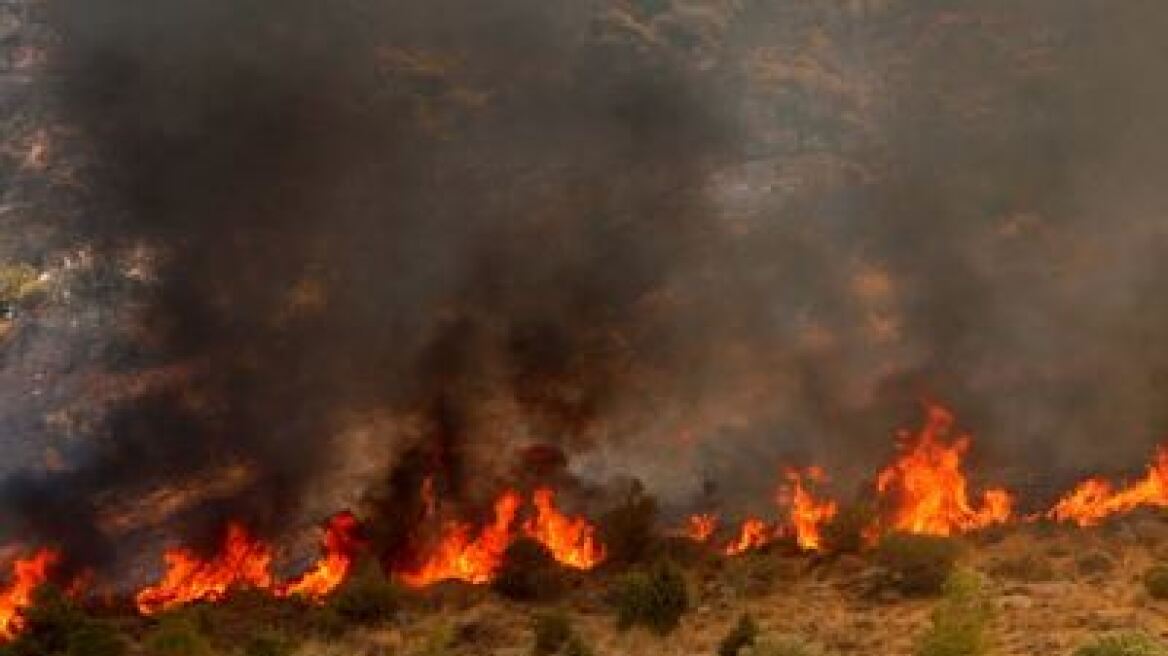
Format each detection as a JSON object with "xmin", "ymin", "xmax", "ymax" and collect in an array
[{"xmin": 612, "ymin": 560, "xmax": 689, "ymax": 635}]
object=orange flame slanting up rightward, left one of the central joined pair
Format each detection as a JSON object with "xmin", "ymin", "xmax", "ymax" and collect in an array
[{"xmin": 399, "ymin": 491, "xmax": 522, "ymax": 587}]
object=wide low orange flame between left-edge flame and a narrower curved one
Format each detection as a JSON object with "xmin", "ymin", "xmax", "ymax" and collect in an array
[{"xmin": 135, "ymin": 522, "xmax": 272, "ymax": 615}]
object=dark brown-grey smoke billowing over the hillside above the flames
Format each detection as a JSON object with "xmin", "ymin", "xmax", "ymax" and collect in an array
[{"xmin": 0, "ymin": 0, "xmax": 1168, "ymax": 569}]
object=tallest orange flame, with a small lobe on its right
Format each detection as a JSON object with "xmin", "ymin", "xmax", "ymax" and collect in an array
[{"xmin": 876, "ymin": 405, "xmax": 1013, "ymax": 536}]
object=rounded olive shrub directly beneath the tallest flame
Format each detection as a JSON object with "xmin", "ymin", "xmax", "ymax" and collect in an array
[{"xmin": 876, "ymin": 533, "xmax": 961, "ymax": 595}]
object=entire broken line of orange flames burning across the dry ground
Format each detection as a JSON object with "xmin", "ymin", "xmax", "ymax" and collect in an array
[{"xmin": 0, "ymin": 399, "xmax": 1168, "ymax": 642}]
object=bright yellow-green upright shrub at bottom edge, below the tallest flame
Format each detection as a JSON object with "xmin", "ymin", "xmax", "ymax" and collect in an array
[{"xmin": 915, "ymin": 571, "xmax": 993, "ymax": 656}]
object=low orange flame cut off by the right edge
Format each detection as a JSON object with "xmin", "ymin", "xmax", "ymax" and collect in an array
[{"xmin": 1048, "ymin": 447, "xmax": 1168, "ymax": 526}]
